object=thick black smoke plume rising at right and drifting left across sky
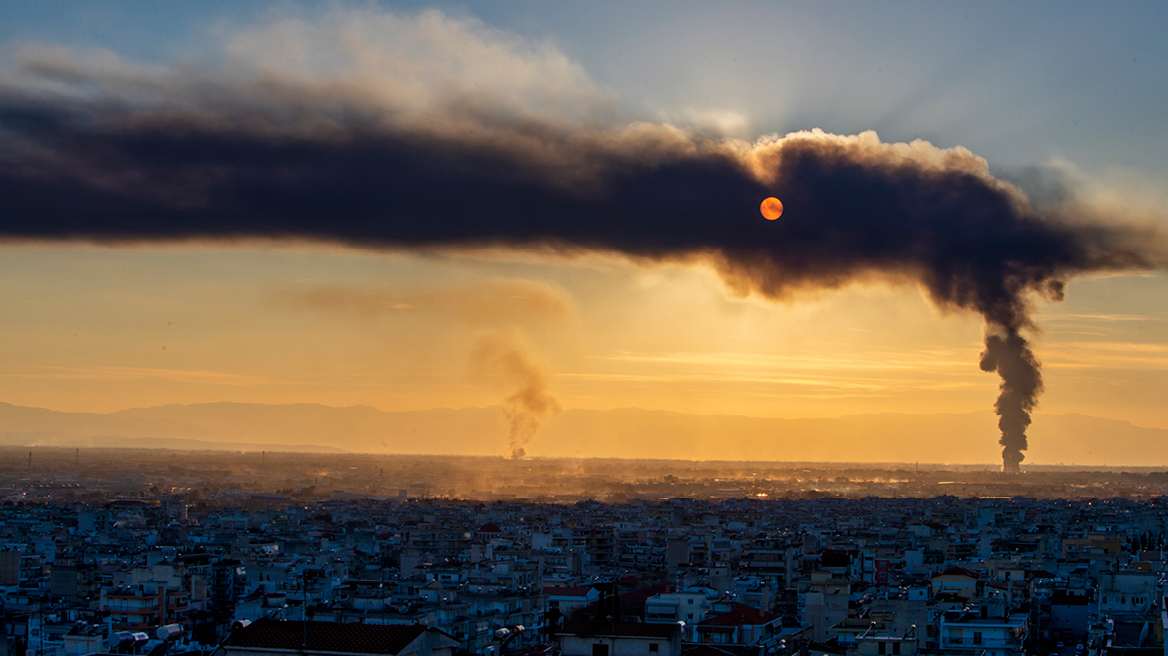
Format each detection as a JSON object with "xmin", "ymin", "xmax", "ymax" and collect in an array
[{"xmin": 0, "ymin": 33, "xmax": 1163, "ymax": 469}]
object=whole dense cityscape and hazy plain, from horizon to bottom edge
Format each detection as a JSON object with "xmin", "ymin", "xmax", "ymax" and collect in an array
[{"xmin": 0, "ymin": 448, "xmax": 1168, "ymax": 656}]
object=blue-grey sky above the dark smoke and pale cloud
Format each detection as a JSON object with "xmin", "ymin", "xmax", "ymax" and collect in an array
[{"xmin": 0, "ymin": 1, "xmax": 1168, "ymax": 176}]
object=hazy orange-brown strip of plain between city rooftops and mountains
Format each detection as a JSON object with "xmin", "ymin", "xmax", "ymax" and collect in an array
[{"xmin": 11, "ymin": 447, "xmax": 1168, "ymax": 499}]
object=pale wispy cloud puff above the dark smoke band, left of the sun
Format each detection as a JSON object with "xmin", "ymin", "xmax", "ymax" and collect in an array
[{"xmin": 224, "ymin": 7, "xmax": 613, "ymax": 128}]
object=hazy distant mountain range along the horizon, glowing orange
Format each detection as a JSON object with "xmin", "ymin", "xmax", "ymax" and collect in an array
[{"xmin": 0, "ymin": 403, "xmax": 1168, "ymax": 466}]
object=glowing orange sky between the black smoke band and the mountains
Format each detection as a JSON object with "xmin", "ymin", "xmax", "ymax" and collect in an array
[{"xmin": 0, "ymin": 245, "xmax": 1168, "ymax": 428}]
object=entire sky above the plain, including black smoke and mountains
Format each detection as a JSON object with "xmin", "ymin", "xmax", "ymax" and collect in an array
[{"xmin": 0, "ymin": 2, "xmax": 1168, "ymax": 469}]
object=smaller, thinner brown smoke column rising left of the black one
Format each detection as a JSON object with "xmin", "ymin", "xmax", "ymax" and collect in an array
[{"xmin": 471, "ymin": 333, "xmax": 563, "ymax": 460}]
